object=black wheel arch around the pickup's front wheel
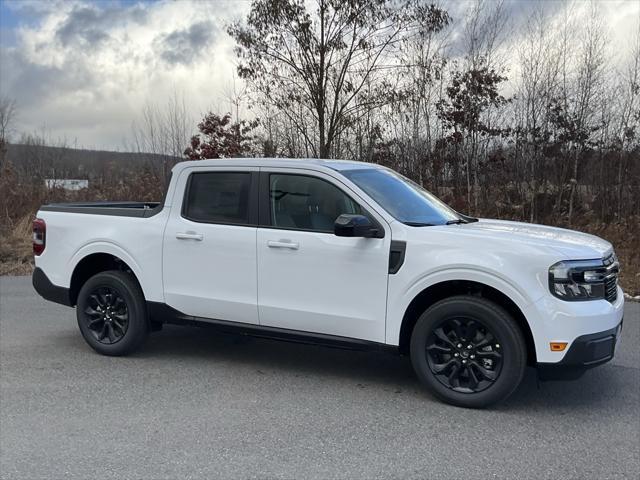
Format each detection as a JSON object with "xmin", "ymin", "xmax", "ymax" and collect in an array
[{"xmin": 398, "ymin": 280, "xmax": 536, "ymax": 365}]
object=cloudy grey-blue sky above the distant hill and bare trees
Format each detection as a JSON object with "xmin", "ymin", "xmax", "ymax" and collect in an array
[{"xmin": 0, "ymin": 0, "xmax": 640, "ymax": 150}]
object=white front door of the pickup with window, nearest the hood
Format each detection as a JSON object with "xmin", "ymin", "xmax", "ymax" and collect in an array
[{"xmin": 257, "ymin": 168, "xmax": 391, "ymax": 342}]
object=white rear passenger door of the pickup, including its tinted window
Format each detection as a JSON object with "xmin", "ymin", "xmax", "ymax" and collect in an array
[{"xmin": 162, "ymin": 167, "xmax": 258, "ymax": 324}]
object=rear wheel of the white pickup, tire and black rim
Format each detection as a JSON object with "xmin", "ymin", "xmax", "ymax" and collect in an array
[{"xmin": 76, "ymin": 270, "xmax": 149, "ymax": 356}]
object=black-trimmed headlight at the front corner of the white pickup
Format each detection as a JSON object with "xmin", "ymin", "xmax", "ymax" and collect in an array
[{"xmin": 549, "ymin": 256, "xmax": 619, "ymax": 301}]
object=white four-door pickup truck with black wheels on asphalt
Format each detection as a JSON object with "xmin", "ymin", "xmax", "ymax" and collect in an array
[{"xmin": 33, "ymin": 159, "xmax": 624, "ymax": 407}]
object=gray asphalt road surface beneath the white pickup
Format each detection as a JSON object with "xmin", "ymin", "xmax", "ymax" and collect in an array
[{"xmin": 0, "ymin": 277, "xmax": 640, "ymax": 480}]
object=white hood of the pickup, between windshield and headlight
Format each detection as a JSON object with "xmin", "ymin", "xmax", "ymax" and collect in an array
[{"xmin": 458, "ymin": 218, "xmax": 613, "ymax": 260}]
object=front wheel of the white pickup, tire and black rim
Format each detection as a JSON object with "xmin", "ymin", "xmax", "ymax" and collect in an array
[{"xmin": 410, "ymin": 295, "xmax": 527, "ymax": 408}]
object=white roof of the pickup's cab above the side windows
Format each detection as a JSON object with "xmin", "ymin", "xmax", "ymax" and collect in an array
[{"xmin": 174, "ymin": 158, "xmax": 381, "ymax": 171}]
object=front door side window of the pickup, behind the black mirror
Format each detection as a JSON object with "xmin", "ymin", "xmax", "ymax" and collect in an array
[{"xmin": 269, "ymin": 173, "xmax": 362, "ymax": 232}]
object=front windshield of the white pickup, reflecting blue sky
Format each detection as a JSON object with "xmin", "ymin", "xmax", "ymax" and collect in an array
[{"xmin": 340, "ymin": 168, "xmax": 466, "ymax": 226}]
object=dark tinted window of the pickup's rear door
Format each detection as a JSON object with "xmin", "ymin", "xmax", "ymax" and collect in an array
[{"xmin": 182, "ymin": 172, "xmax": 251, "ymax": 224}]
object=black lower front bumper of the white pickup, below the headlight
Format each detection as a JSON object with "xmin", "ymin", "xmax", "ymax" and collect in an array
[{"xmin": 538, "ymin": 321, "xmax": 623, "ymax": 380}]
